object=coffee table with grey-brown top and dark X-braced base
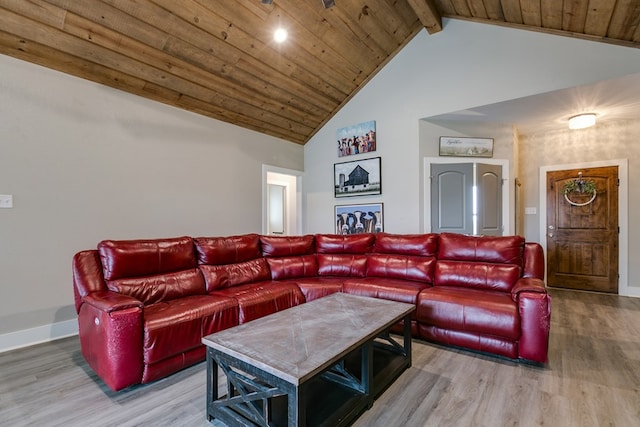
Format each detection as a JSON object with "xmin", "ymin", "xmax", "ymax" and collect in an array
[{"xmin": 202, "ymin": 293, "xmax": 415, "ymax": 426}]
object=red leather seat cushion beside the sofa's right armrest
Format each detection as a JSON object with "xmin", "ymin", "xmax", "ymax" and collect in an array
[{"xmin": 416, "ymin": 286, "xmax": 520, "ymax": 341}]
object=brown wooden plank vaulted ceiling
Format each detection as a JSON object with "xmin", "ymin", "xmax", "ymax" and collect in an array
[{"xmin": 0, "ymin": 0, "xmax": 640, "ymax": 144}]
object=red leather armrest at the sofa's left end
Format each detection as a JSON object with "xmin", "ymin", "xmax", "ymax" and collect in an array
[{"xmin": 78, "ymin": 291, "xmax": 143, "ymax": 391}]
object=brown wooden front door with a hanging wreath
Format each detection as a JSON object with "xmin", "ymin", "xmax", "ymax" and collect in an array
[{"xmin": 546, "ymin": 166, "xmax": 619, "ymax": 293}]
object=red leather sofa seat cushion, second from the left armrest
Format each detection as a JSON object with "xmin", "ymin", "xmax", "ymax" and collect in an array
[{"xmin": 210, "ymin": 281, "xmax": 304, "ymax": 323}]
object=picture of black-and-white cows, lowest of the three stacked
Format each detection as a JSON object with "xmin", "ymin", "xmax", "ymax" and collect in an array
[{"xmin": 333, "ymin": 203, "xmax": 384, "ymax": 234}]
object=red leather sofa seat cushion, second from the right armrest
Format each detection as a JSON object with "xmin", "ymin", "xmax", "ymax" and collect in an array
[{"xmin": 342, "ymin": 277, "xmax": 429, "ymax": 319}]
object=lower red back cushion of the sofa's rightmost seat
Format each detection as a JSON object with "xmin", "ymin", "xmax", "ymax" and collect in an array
[{"xmin": 434, "ymin": 260, "xmax": 522, "ymax": 292}]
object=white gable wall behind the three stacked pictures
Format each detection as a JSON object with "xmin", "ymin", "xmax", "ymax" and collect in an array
[{"xmin": 304, "ymin": 19, "xmax": 640, "ymax": 237}]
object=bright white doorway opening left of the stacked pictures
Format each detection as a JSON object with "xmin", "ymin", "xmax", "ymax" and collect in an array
[{"xmin": 262, "ymin": 165, "xmax": 302, "ymax": 236}]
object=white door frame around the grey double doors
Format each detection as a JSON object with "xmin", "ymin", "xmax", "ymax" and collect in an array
[{"xmin": 422, "ymin": 157, "xmax": 515, "ymax": 236}]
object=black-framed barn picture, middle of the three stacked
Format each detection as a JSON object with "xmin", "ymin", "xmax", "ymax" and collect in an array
[{"xmin": 333, "ymin": 157, "xmax": 382, "ymax": 197}]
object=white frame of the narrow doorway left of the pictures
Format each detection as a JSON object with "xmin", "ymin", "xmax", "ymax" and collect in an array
[{"xmin": 262, "ymin": 164, "xmax": 304, "ymax": 235}]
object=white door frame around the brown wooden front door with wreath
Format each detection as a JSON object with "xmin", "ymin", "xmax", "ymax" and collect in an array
[{"xmin": 538, "ymin": 159, "xmax": 640, "ymax": 297}]
